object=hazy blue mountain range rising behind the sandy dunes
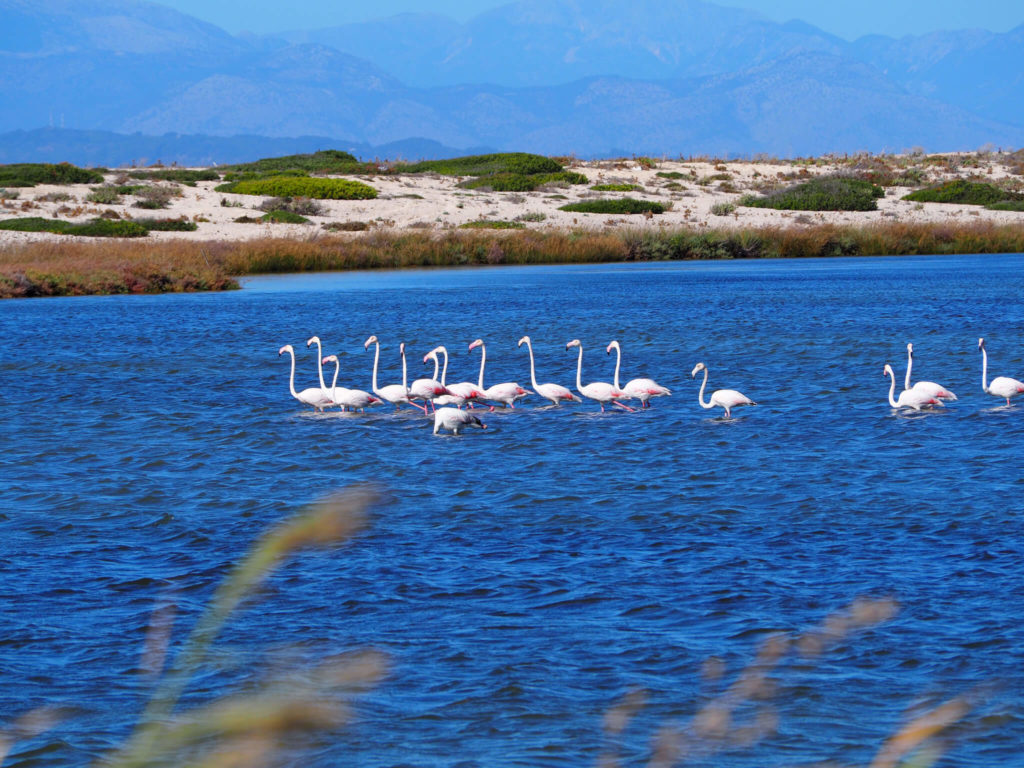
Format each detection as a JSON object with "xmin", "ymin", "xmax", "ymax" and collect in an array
[{"xmin": 0, "ymin": 0, "xmax": 1024, "ymax": 163}]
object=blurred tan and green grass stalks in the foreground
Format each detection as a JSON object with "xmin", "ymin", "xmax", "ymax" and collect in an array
[{"xmin": 0, "ymin": 486, "xmax": 997, "ymax": 768}]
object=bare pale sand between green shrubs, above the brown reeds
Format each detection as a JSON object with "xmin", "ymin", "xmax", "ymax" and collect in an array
[{"xmin": 0, "ymin": 155, "xmax": 1024, "ymax": 246}]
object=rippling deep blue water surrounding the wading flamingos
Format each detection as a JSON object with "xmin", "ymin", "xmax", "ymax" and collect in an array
[{"xmin": 0, "ymin": 255, "xmax": 1024, "ymax": 767}]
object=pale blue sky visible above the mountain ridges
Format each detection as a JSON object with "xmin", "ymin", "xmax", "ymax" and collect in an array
[{"xmin": 157, "ymin": 0, "xmax": 1024, "ymax": 40}]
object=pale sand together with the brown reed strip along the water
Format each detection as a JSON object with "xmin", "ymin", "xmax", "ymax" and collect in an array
[{"xmin": 0, "ymin": 153, "xmax": 1024, "ymax": 298}]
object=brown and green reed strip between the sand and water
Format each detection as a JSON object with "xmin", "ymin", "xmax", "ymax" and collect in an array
[{"xmin": 0, "ymin": 221, "xmax": 1024, "ymax": 298}]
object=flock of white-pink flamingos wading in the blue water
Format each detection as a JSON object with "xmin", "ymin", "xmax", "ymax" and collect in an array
[{"xmin": 278, "ymin": 336, "xmax": 1024, "ymax": 434}]
